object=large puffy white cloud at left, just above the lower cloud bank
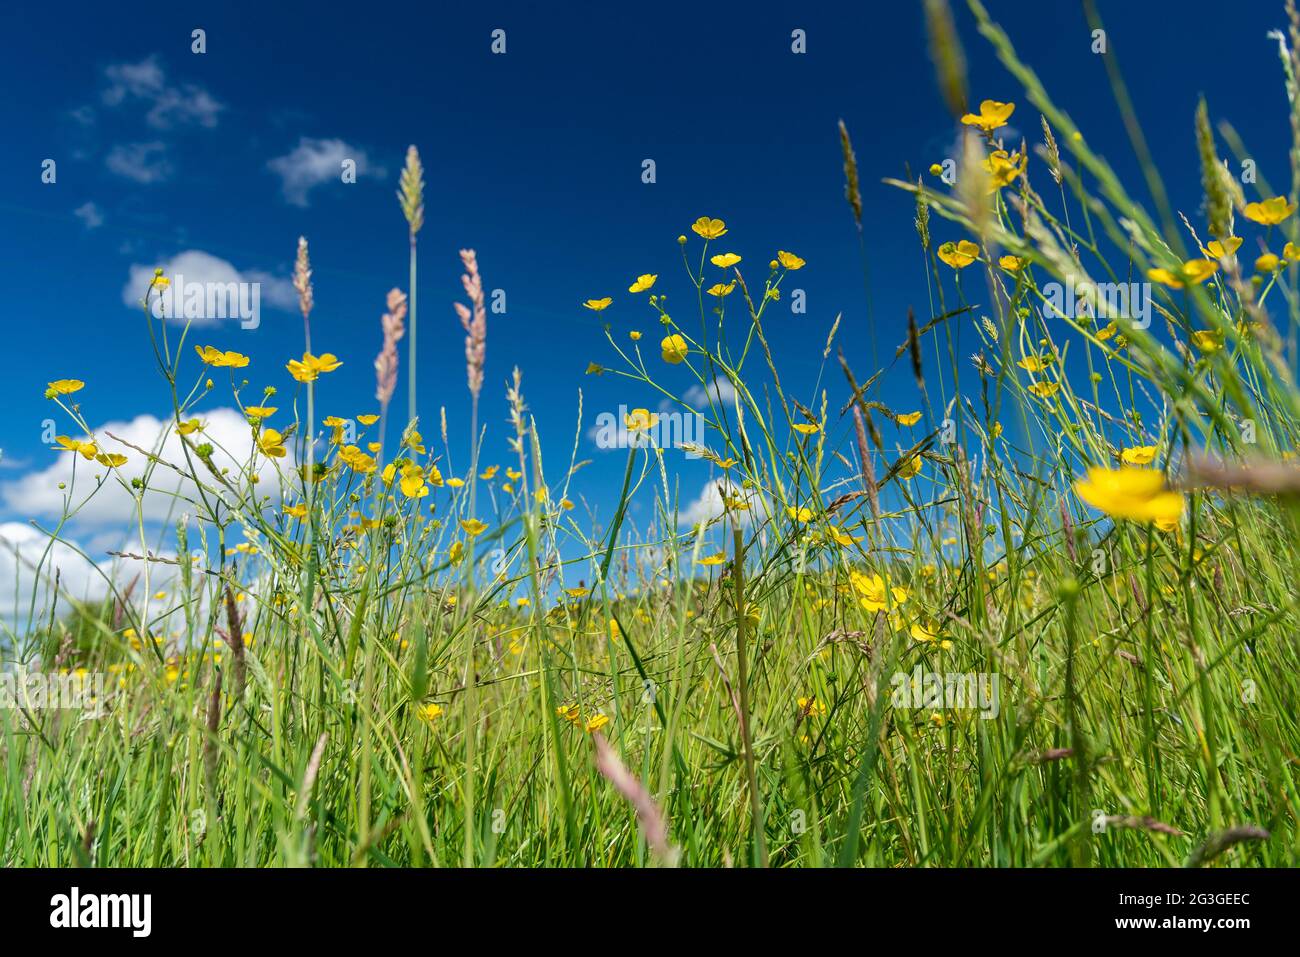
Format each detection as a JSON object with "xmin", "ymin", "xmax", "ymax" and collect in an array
[{"xmin": 0, "ymin": 408, "xmax": 293, "ymax": 532}]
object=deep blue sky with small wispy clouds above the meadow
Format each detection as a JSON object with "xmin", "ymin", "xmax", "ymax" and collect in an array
[{"xmin": 0, "ymin": 0, "xmax": 1290, "ymax": 598}]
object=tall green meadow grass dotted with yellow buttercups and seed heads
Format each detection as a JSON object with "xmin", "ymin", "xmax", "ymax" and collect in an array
[{"xmin": 0, "ymin": 0, "xmax": 1300, "ymax": 867}]
